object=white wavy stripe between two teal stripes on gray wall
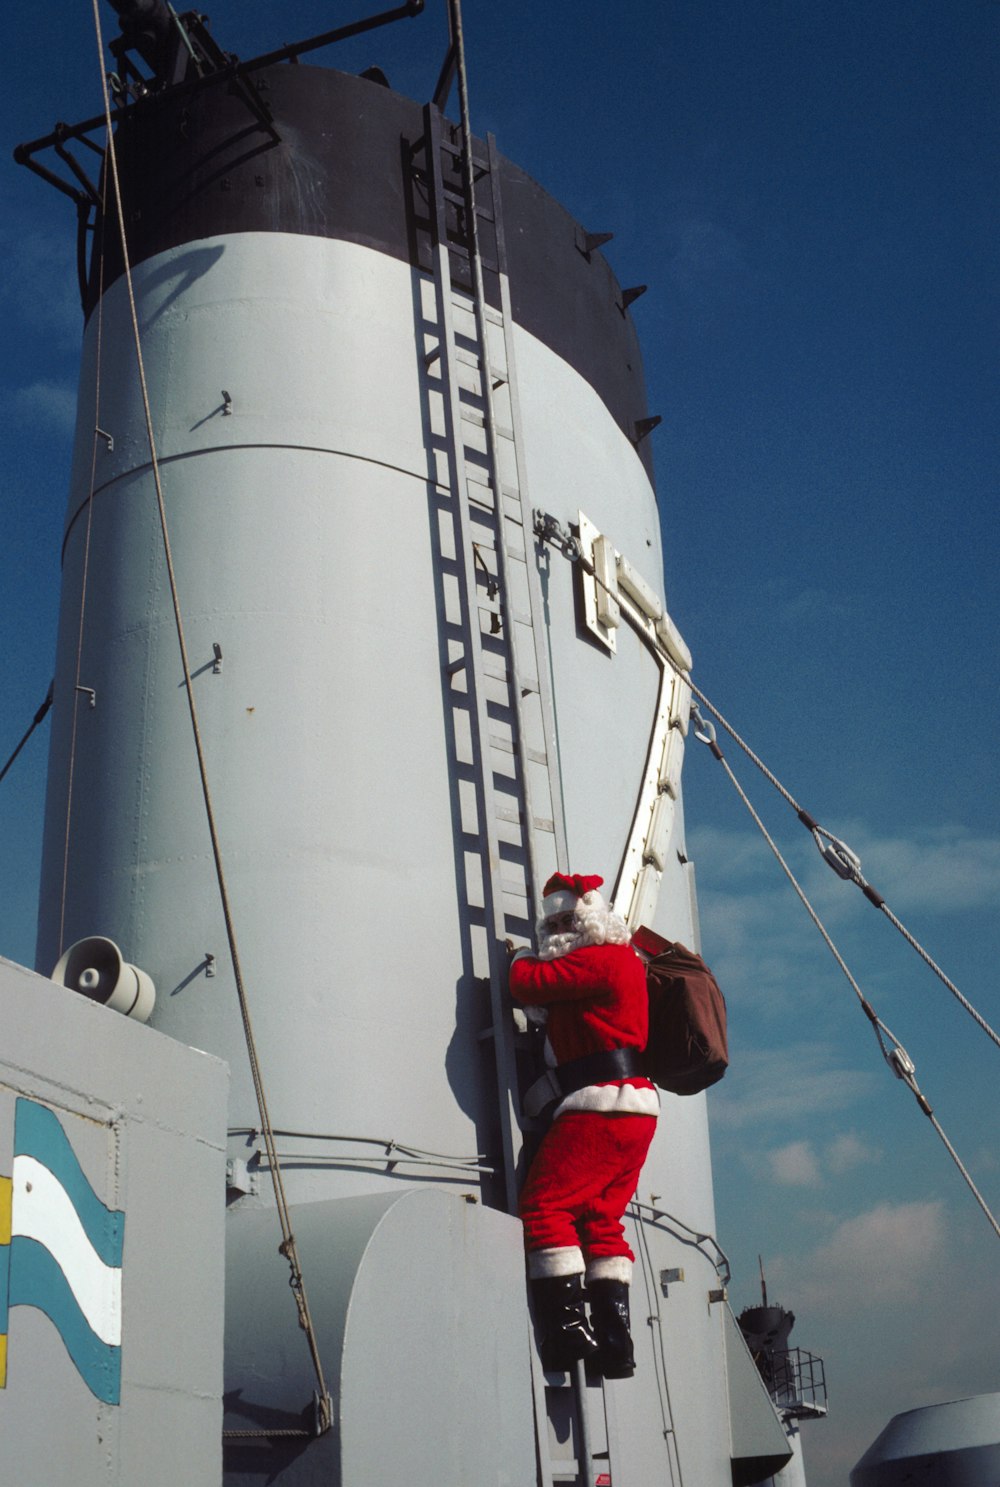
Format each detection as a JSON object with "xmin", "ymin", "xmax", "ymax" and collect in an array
[{"xmin": 10, "ymin": 1155, "xmax": 122, "ymax": 1346}]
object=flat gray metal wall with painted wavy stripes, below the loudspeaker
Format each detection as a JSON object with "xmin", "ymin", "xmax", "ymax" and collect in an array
[{"xmin": 0, "ymin": 959, "xmax": 228, "ymax": 1487}]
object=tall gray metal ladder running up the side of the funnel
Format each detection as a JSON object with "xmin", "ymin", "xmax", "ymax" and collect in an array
[{"xmin": 424, "ymin": 106, "xmax": 567, "ymax": 1213}]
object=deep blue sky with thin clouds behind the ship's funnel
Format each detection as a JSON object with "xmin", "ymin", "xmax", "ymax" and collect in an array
[{"xmin": 0, "ymin": 0, "xmax": 1000, "ymax": 1487}]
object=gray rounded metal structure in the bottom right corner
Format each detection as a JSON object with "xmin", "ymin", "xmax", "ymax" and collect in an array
[{"xmin": 851, "ymin": 1393, "xmax": 1000, "ymax": 1487}]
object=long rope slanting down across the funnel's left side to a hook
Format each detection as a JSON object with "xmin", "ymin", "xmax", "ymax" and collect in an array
[{"xmin": 92, "ymin": 0, "xmax": 333, "ymax": 1435}]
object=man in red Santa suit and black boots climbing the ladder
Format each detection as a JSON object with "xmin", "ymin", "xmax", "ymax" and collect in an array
[{"xmin": 510, "ymin": 873, "xmax": 659, "ymax": 1378}]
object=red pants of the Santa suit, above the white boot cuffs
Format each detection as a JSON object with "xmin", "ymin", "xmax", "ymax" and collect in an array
[{"xmin": 521, "ymin": 1111, "xmax": 656, "ymax": 1259}]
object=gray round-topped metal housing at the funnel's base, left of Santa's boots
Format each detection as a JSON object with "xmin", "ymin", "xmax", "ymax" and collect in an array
[{"xmin": 226, "ymin": 1188, "xmax": 536, "ymax": 1487}]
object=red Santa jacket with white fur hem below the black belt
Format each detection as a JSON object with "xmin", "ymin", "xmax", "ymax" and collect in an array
[{"xmin": 510, "ymin": 944, "xmax": 659, "ymax": 1115}]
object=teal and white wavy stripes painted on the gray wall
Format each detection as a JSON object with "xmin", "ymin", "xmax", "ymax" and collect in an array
[{"xmin": 0, "ymin": 1099, "xmax": 125, "ymax": 1404}]
